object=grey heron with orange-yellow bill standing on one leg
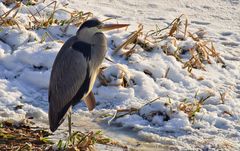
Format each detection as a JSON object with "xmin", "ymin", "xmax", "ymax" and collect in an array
[{"xmin": 48, "ymin": 19, "xmax": 128, "ymax": 135}]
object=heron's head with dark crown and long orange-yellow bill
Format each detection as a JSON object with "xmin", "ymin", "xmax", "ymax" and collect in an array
[{"xmin": 77, "ymin": 18, "xmax": 129, "ymax": 39}]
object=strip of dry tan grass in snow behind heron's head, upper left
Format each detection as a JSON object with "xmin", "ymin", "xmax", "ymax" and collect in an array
[{"xmin": 0, "ymin": 0, "xmax": 92, "ymax": 33}]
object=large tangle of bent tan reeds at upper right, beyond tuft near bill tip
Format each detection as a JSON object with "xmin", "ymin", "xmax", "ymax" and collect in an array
[{"xmin": 146, "ymin": 14, "xmax": 225, "ymax": 73}]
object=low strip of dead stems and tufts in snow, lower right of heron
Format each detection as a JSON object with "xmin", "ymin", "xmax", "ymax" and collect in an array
[{"xmin": 108, "ymin": 92, "xmax": 213, "ymax": 124}]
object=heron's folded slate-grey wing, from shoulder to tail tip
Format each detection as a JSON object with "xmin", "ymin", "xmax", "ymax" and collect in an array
[{"xmin": 49, "ymin": 37, "xmax": 91, "ymax": 131}]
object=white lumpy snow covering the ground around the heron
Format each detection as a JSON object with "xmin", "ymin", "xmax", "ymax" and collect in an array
[{"xmin": 0, "ymin": 0, "xmax": 240, "ymax": 150}]
